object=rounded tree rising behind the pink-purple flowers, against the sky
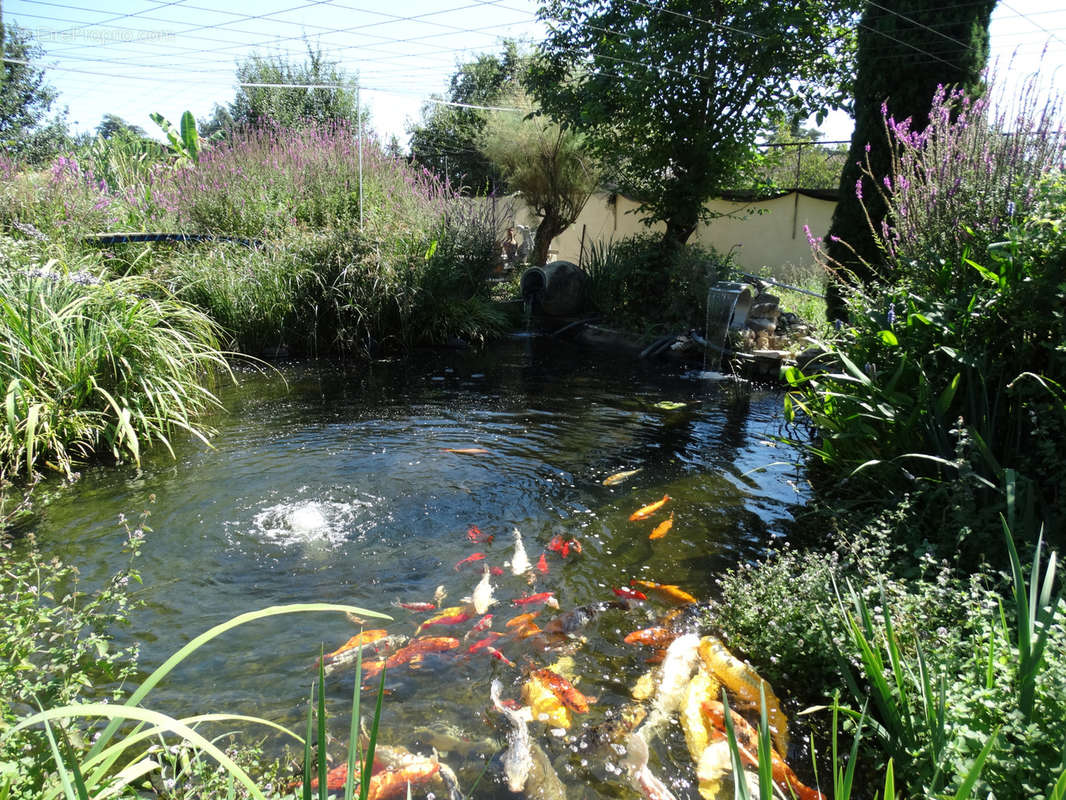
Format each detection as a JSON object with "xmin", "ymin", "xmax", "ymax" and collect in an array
[{"xmin": 228, "ymin": 45, "xmax": 358, "ymax": 129}]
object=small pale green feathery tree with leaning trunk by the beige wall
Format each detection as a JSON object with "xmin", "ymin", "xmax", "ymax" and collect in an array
[{"xmin": 480, "ymin": 86, "xmax": 599, "ymax": 265}]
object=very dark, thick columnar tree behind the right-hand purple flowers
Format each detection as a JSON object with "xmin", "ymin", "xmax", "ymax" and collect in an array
[{"xmin": 826, "ymin": 0, "xmax": 996, "ymax": 319}]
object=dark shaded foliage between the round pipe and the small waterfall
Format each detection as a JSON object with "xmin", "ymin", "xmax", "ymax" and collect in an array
[{"xmin": 584, "ymin": 234, "xmax": 730, "ymax": 331}]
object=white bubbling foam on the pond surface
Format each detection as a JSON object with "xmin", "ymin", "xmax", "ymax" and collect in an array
[{"xmin": 249, "ymin": 500, "xmax": 371, "ymax": 547}]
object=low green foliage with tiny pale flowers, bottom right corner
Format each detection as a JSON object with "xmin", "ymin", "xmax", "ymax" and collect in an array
[{"xmin": 715, "ymin": 508, "xmax": 1066, "ymax": 798}]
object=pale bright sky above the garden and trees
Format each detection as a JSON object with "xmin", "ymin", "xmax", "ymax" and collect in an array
[{"xmin": 6, "ymin": 0, "xmax": 1066, "ymax": 144}]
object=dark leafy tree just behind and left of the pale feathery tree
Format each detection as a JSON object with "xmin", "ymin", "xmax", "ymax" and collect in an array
[{"xmin": 409, "ymin": 41, "xmax": 529, "ymax": 192}]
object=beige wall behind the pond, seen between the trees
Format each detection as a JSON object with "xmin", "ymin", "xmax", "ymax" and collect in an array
[{"xmin": 497, "ymin": 193, "xmax": 836, "ymax": 273}]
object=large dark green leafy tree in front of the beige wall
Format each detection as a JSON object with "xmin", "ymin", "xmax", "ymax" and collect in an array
[{"xmin": 531, "ymin": 0, "xmax": 855, "ymax": 263}]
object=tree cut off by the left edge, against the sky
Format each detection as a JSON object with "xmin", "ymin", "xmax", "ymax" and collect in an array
[{"xmin": 0, "ymin": 22, "xmax": 68, "ymax": 162}]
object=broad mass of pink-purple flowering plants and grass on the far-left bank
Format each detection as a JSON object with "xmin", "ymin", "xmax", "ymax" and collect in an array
[{"xmin": 151, "ymin": 123, "xmax": 505, "ymax": 353}]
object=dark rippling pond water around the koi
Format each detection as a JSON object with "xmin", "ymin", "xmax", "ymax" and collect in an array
[{"xmin": 20, "ymin": 337, "xmax": 805, "ymax": 797}]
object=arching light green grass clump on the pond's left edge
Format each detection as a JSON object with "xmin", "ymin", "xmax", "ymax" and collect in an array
[{"xmin": 0, "ymin": 240, "xmax": 227, "ymax": 477}]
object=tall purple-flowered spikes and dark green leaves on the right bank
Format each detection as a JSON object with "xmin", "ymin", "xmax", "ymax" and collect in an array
[{"xmin": 789, "ymin": 75, "xmax": 1066, "ymax": 551}]
